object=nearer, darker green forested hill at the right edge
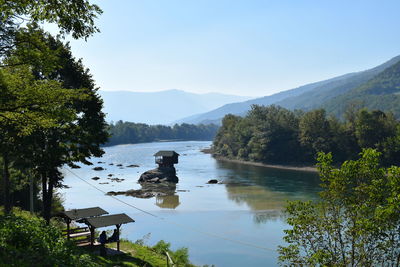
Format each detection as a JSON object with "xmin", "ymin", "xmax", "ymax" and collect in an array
[{"xmin": 322, "ymin": 59, "xmax": 400, "ymax": 118}]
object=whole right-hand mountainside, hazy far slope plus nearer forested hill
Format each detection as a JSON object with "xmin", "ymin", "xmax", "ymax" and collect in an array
[{"xmin": 177, "ymin": 56, "xmax": 400, "ymax": 124}]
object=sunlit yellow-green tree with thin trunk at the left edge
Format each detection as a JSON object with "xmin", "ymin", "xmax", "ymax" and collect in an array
[{"xmin": 0, "ymin": 66, "xmax": 79, "ymax": 215}]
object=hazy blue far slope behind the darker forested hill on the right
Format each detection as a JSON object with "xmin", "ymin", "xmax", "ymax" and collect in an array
[{"xmin": 178, "ymin": 56, "xmax": 400, "ymax": 123}]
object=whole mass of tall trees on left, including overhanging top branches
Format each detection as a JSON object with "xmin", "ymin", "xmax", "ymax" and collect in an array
[{"xmin": 0, "ymin": 0, "xmax": 108, "ymax": 220}]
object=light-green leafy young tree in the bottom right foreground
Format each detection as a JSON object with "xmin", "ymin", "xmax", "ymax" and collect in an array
[{"xmin": 279, "ymin": 149, "xmax": 400, "ymax": 266}]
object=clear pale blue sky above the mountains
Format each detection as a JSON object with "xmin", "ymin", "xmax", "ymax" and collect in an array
[{"xmin": 67, "ymin": 0, "xmax": 400, "ymax": 96}]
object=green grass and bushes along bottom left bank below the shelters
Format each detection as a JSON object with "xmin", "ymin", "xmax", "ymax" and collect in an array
[{"xmin": 0, "ymin": 209, "xmax": 203, "ymax": 267}]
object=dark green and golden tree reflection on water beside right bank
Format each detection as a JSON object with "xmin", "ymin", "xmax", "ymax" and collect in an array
[{"xmin": 217, "ymin": 161, "xmax": 321, "ymax": 224}]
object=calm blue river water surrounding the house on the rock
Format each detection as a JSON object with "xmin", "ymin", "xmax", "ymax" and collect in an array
[{"xmin": 61, "ymin": 141, "xmax": 320, "ymax": 267}]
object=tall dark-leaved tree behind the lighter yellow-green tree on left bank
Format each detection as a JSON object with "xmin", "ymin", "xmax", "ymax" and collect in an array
[{"xmin": 22, "ymin": 36, "xmax": 108, "ymax": 224}]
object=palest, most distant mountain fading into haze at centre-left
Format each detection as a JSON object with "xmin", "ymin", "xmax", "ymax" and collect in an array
[{"xmin": 99, "ymin": 90, "xmax": 250, "ymax": 124}]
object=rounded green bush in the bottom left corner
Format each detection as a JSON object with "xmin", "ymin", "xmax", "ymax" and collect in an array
[{"xmin": 0, "ymin": 212, "xmax": 93, "ymax": 266}]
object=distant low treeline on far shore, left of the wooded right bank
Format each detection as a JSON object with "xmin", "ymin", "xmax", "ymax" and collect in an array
[{"xmin": 106, "ymin": 121, "xmax": 219, "ymax": 146}]
